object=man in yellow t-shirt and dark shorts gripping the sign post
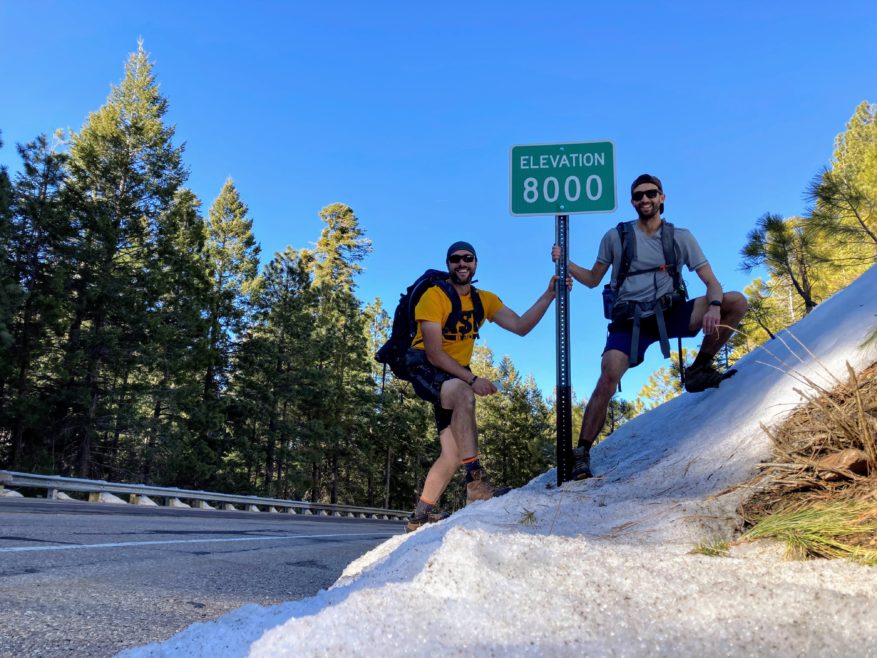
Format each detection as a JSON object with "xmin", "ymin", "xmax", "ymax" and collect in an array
[{"xmin": 408, "ymin": 241, "xmax": 557, "ymax": 532}]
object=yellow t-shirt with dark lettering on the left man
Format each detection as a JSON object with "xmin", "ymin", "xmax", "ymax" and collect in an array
[{"xmin": 411, "ymin": 286, "xmax": 503, "ymax": 367}]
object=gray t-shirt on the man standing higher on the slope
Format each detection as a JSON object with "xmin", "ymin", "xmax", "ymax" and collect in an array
[{"xmin": 597, "ymin": 223, "xmax": 707, "ymax": 315}]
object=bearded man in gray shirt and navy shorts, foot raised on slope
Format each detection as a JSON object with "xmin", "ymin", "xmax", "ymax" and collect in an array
[{"xmin": 552, "ymin": 174, "xmax": 747, "ymax": 480}]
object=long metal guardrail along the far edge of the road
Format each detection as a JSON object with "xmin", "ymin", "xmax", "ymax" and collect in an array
[{"xmin": 0, "ymin": 471, "xmax": 409, "ymax": 519}]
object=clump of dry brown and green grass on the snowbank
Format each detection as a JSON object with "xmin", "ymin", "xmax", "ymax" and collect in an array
[{"xmin": 739, "ymin": 363, "xmax": 877, "ymax": 564}]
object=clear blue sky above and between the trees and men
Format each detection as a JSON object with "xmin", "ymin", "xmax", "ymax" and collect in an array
[{"xmin": 0, "ymin": 0, "xmax": 877, "ymax": 399}]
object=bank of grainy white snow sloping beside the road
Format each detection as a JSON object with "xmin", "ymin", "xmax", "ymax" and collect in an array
[{"xmin": 122, "ymin": 267, "xmax": 877, "ymax": 658}]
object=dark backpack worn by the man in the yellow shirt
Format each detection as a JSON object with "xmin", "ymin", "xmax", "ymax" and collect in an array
[{"xmin": 375, "ymin": 270, "xmax": 484, "ymax": 380}]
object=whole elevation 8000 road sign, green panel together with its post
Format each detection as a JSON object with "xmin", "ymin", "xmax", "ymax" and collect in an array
[{"xmin": 509, "ymin": 142, "xmax": 616, "ymax": 486}]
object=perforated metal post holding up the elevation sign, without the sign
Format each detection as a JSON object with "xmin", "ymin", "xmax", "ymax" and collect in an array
[{"xmin": 554, "ymin": 215, "xmax": 573, "ymax": 486}]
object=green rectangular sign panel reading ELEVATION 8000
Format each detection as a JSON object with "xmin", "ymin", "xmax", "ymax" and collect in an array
[{"xmin": 509, "ymin": 142, "xmax": 616, "ymax": 215}]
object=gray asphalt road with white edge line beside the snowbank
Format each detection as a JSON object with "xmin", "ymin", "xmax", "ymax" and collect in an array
[{"xmin": 0, "ymin": 498, "xmax": 404, "ymax": 658}]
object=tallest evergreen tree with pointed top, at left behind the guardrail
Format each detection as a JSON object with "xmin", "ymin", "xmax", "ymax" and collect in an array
[{"xmin": 55, "ymin": 41, "xmax": 186, "ymax": 477}]
